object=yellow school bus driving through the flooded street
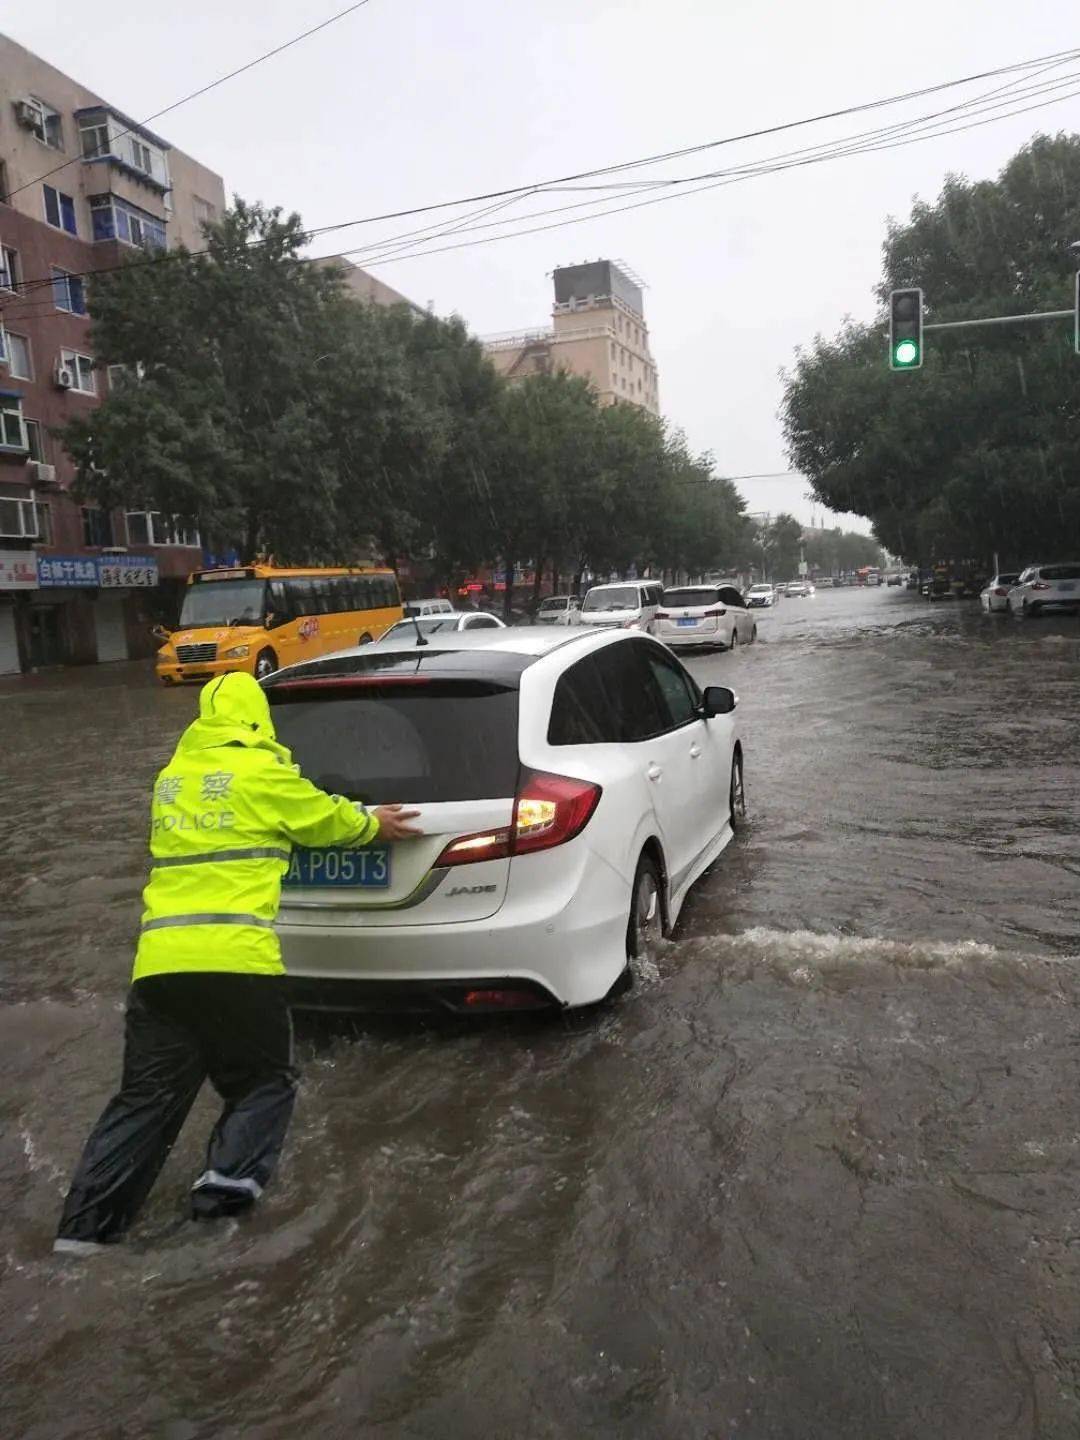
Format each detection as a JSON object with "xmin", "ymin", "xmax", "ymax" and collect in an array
[{"xmin": 157, "ymin": 564, "xmax": 402, "ymax": 685}]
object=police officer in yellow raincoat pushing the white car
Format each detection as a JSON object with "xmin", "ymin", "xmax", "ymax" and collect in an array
[{"xmin": 53, "ymin": 674, "xmax": 419, "ymax": 1253}]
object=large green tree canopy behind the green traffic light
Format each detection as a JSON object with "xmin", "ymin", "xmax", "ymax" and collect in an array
[{"xmin": 782, "ymin": 135, "xmax": 1080, "ymax": 566}]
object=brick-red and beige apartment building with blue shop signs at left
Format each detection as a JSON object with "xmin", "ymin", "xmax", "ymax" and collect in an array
[{"xmin": 0, "ymin": 36, "xmax": 225, "ymax": 674}]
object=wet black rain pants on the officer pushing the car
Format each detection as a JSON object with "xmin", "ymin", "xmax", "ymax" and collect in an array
[{"xmin": 58, "ymin": 972, "xmax": 297, "ymax": 1243}]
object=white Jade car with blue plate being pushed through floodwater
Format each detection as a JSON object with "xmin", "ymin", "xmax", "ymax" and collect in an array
[{"xmin": 266, "ymin": 626, "xmax": 744, "ymax": 1012}]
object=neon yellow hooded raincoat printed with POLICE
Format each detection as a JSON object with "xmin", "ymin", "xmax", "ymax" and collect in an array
[{"xmin": 132, "ymin": 672, "xmax": 379, "ymax": 981}]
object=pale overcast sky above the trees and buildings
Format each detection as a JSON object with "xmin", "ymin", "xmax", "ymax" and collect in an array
[{"xmin": 10, "ymin": 0, "xmax": 1080, "ymax": 528}]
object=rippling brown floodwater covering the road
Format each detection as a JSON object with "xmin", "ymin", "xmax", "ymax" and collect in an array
[{"xmin": 0, "ymin": 590, "xmax": 1080, "ymax": 1440}]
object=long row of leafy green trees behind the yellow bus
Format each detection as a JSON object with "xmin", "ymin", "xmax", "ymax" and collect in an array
[{"xmin": 63, "ymin": 200, "xmax": 749, "ymax": 583}]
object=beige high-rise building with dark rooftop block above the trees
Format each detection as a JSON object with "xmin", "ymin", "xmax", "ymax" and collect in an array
[{"xmin": 484, "ymin": 261, "xmax": 660, "ymax": 415}]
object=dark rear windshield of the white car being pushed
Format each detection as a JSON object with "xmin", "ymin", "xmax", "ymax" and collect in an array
[{"xmin": 268, "ymin": 677, "xmax": 518, "ymax": 805}]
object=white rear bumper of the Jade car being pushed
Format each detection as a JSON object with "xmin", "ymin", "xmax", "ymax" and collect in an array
[{"xmin": 276, "ymin": 852, "xmax": 631, "ymax": 1009}]
